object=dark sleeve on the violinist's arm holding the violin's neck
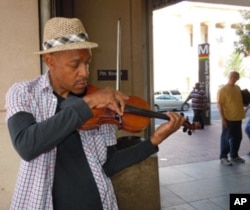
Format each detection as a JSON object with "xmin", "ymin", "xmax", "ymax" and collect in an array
[{"xmin": 103, "ymin": 139, "xmax": 159, "ymax": 176}]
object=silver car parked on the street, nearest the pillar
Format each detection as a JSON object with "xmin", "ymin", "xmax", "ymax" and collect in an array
[{"xmin": 154, "ymin": 94, "xmax": 190, "ymax": 112}]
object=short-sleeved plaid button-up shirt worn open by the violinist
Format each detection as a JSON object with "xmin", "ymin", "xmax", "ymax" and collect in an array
[{"xmin": 6, "ymin": 72, "xmax": 118, "ymax": 210}]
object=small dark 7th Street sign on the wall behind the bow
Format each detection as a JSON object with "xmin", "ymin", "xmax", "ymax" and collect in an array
[{"xmin": 97, "ymin": 70, "xmax": 128, "ymax": 81}]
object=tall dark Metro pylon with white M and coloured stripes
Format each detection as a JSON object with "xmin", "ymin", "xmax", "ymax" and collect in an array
[{"xmin": 198, "ymin": 43, "xmax": 211, "ymax": 125}]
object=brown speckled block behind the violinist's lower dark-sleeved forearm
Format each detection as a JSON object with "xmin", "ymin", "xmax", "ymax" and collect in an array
[{"xmin": 112, "ymin": 137, "xmax": 161, "ymax": 210}]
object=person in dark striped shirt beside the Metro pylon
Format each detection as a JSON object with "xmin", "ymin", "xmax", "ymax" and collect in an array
[{"xmin": 182, "ymin": 82, "xmax": 208, "ymax": 129}]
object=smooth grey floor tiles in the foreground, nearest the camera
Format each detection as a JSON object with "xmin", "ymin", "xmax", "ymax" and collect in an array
[{"xmin": 159, "ymin": 155, "xmax": 250, "ymax": 210}]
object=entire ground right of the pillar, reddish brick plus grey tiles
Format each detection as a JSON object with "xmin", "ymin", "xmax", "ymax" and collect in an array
[{"xmin": 158, "ymin": 122, "xmax": 250, "ymax": 210}]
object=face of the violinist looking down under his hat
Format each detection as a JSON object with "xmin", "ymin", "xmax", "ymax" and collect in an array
[{"xmin": 44, "ymin": 49, "xmax": 91, "ymax": 98}]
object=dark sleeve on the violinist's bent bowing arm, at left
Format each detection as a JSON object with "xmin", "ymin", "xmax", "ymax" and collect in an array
[{"xmin": 7, "ymin": 96, "xmax": 92, "ymax": 161}]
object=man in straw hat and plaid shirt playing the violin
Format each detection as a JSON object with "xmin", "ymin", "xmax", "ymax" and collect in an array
[{"xmin": 6, "ymin": 18, "xmax": 185, "ymax": 210}]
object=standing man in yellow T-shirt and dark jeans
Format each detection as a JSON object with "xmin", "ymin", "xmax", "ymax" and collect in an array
[{"xmin": 217, "ymin": 71, "xmax": 245, "ymax": 166}]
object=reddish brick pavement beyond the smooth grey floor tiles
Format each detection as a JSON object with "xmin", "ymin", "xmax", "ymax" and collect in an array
[{"xmin": 158, "ymin": 120, "xmax": 250, "ymax": 167}]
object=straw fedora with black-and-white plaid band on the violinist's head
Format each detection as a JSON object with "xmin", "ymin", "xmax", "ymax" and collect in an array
[{"xmin": 35, "ymin": 17, "xmax": 98, "ymax": 54}]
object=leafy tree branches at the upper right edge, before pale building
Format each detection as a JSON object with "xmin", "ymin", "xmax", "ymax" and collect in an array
[{"xmin": 234, "ymin": 10, "xmax": 250, "ymax": 56}]
